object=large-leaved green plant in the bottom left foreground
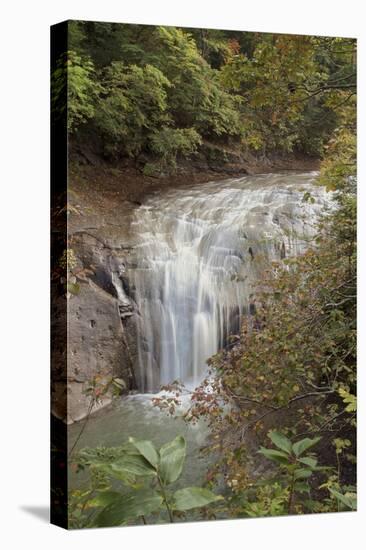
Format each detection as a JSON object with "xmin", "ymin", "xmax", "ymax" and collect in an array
[{"xmin": 70, "ymin": 436, "xmax": 222, "ymax": 527}]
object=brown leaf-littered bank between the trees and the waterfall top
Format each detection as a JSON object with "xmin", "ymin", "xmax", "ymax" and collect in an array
[{"xmin": 69, "ymin": 150, "xmax": 320, "ymax": 208}]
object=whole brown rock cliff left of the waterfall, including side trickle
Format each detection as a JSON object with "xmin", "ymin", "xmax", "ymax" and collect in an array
[{"xmin": 52, "ymin": 176, "xmax": 143, "ymax": 423}]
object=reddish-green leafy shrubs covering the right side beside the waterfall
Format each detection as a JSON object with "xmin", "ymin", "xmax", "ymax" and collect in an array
[{"xmin": 155, "ymin": 104, "xmax": 357, "ymax": 517}]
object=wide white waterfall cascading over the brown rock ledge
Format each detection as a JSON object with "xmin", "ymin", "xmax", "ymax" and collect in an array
[{"xmin": 129, "ymin": 173, "xmax": 329, "ymax": 392}]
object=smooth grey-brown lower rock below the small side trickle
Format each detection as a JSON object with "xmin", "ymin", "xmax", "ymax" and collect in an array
[{"xmin": 52, "ymin": 279, "xmax": 134, "ymax": 424}]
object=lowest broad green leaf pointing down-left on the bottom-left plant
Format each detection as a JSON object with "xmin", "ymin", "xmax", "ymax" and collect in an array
[{"xmin": 93, "ymin": 490, "xmax": 163, "ymax": 527}]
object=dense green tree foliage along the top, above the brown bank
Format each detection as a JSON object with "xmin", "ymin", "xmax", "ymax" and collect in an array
[{"xmin": 53, "ymin": 21, "xmax": 356, "ymax": 173}]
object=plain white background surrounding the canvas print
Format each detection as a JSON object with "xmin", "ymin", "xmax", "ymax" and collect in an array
[{"xmin": 0, "ymin": 0, "xmax": 366, "ymax": 550}]
